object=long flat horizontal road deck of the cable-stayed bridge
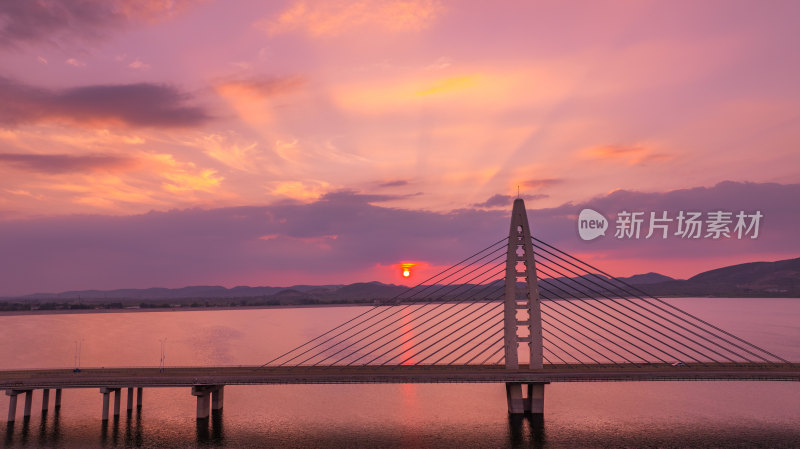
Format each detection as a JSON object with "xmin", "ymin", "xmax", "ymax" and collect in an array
[{"xmin": 0, "ymin": 364, "xmax": 800, "ymax": 390}]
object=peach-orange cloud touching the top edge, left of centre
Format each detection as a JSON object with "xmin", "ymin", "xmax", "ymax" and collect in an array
[{"xmin": 258, "ymin": 0, "xmax": 444, "ymax": 37}]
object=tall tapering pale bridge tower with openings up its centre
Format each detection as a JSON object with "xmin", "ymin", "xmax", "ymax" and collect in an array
[{"xmin": 504, "ymin": 198, "xmax": 544, "ymax": 414}]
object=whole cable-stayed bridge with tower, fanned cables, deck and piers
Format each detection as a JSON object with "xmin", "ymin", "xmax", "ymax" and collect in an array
[{"xmin": 0, "ymin": 199, "xmax": 800, "ymax": 421}]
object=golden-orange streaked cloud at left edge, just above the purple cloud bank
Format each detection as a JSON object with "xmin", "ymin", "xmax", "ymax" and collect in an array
[{"xmin": 0, "ymin": 148, "xmax": 231, "ymax": 217}]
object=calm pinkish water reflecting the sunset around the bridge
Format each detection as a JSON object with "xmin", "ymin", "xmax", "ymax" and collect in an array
[{"xmin": 0, "ymin": 298, "xmax": 800, "ymax": 448}]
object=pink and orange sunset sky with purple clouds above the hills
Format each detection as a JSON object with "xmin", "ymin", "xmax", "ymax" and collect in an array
[{"xmin": 0, "ymin": 0, "xmax": 800, "ymax": 295}]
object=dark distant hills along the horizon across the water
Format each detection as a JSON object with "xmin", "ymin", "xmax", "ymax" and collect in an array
[{"xmin": 4, "ymin": 258, "xmax": 800, "ymax": 308}]
